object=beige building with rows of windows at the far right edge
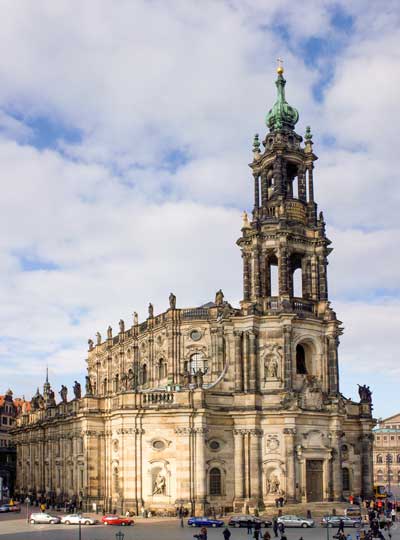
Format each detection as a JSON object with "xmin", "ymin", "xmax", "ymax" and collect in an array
[{"xmin": 373, "ymin": 413, "xmax": 400, "ymax": 492}]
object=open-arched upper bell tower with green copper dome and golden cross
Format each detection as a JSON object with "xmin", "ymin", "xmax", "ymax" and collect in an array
[{"xmin": 238, "ymin": 66, "xmax": 331, "ymax": 314}]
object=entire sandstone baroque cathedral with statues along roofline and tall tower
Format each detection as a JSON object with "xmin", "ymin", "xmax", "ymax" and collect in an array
[{"xmin": 14, "ymin": 66, "xmax": 374, "ymax": 515}]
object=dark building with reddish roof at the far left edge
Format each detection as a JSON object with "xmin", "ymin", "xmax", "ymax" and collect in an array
[{"xmin": 0, "ymin": 390, "xmax": 28, "ymax": 499}]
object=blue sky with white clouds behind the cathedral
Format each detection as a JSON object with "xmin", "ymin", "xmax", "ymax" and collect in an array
[{"xmin": 0, "ymin": 0, "xmax": 400, "ymax": 418}]
